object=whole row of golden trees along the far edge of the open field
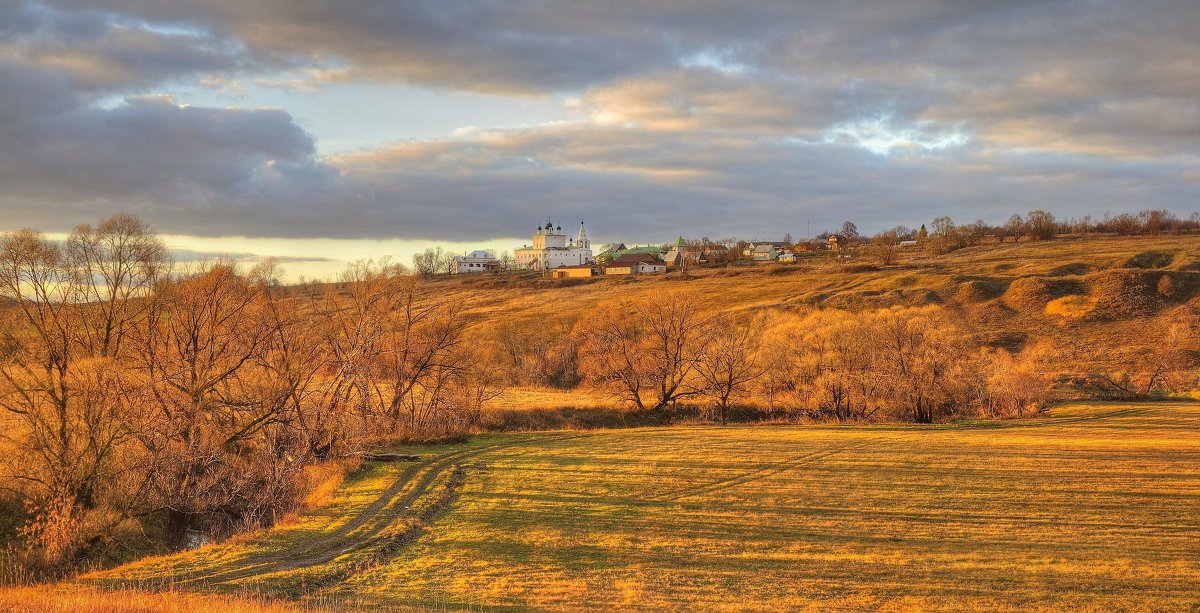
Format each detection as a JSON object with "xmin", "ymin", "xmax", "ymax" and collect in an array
[{"xmin": 479, "ymin": 290, "xmax": 1200, "ymax": 423}]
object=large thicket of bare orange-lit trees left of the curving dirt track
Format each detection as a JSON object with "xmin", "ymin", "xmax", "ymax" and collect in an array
[{"xmin": 0, "ymin": 215, "xmax": 497, "ymax": 571}]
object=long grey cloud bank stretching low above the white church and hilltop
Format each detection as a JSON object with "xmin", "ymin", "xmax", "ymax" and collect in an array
[{"xmin": 324, "ymin": 127, "xmax": 1196, "ymax": 240}]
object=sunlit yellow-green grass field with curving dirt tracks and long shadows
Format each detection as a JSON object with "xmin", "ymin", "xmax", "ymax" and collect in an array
[{"xmin": 77, "ymin": 403, "xmax": 1200, "ymax": 611}]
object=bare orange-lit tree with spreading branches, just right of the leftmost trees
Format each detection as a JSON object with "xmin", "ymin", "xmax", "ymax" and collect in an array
[{"xmin": 130, "ymin": 263, "xmax": 280, "ymax": 545}]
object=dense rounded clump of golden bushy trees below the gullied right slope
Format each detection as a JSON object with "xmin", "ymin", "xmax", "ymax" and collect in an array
[{"xmin": 763, "ymin": 306, "xmax": 1054, "ymax": 423}]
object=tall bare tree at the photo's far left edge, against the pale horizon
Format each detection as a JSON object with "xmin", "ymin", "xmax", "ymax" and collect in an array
[{"xmin": 0, "ymin": 230, "xmax": 145, "ymax": 558}]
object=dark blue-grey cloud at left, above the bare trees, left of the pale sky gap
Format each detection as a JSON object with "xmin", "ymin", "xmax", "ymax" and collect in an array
[{"xmin": 0, "ymin": 58, "xmax": 349, "ymax": 235}]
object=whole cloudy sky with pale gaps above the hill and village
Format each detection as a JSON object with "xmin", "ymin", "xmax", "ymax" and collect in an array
[{"xmin": 0, "ymin": 0, "xmax": 1200, "ymax": 278}]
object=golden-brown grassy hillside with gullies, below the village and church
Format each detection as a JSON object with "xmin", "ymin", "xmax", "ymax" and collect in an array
[{"xmin": 405, "ymin": 235, "xmax": 1200, "ymax": 409}]
